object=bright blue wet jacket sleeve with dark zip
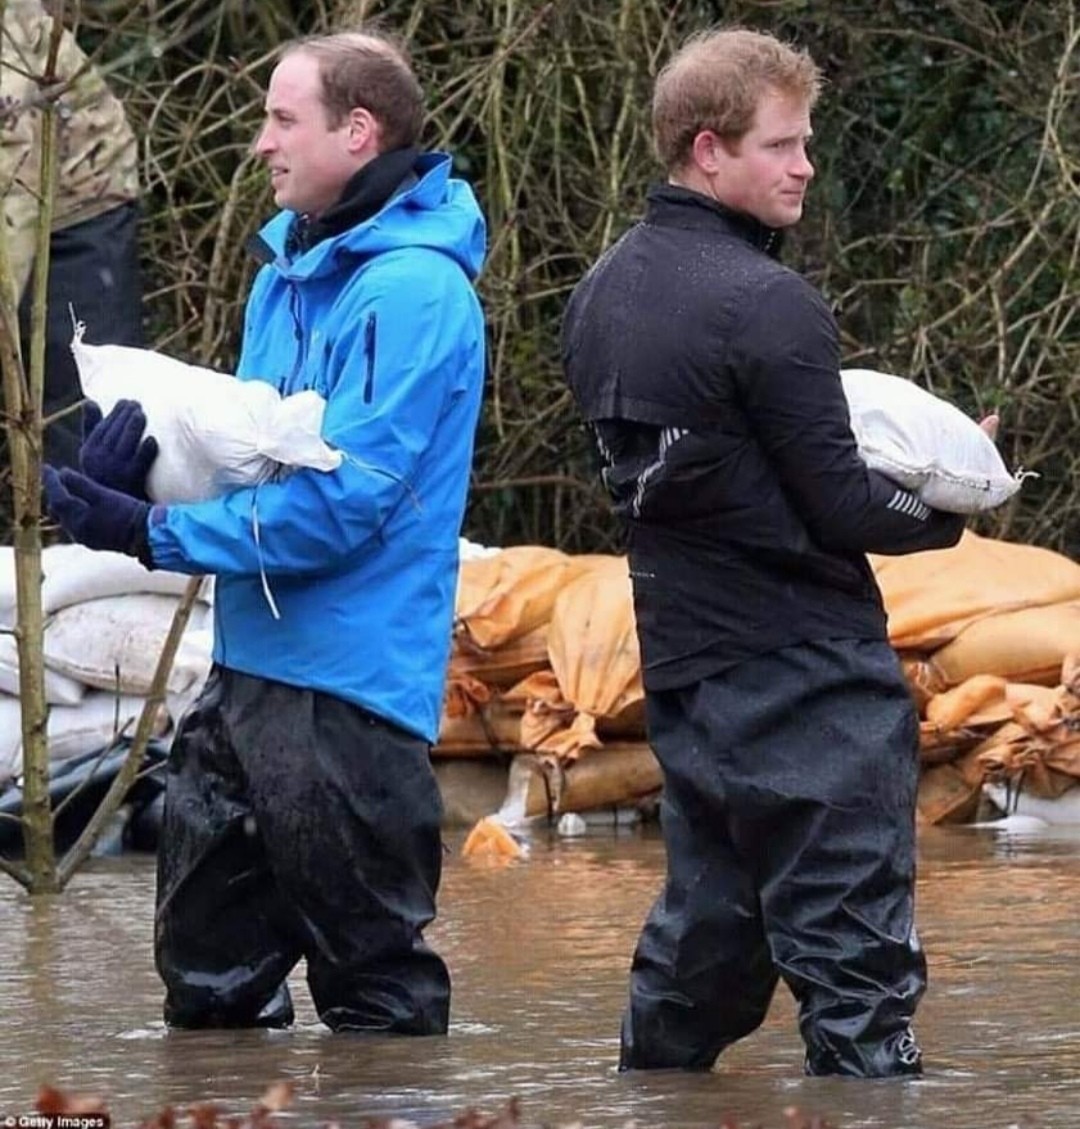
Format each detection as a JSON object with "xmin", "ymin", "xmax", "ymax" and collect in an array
[{"xmin": 150, "ymin": 256, "xmax": 473, "ymax": 576}]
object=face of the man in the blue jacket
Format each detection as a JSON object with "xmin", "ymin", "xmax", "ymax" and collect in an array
[{"xmin": 255, "ymin": 51, "xmax": 362, "ymax": 216}]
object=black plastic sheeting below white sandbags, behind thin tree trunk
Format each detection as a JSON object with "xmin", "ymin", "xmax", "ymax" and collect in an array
[{"xmin": 0, "ymin": 741, "xmax": 168, "ymax": 858}]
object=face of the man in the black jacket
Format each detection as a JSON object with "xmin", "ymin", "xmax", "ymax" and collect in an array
[{"xmin": 711, "ymin": 90, "xmax": 814, "ymax": 227}]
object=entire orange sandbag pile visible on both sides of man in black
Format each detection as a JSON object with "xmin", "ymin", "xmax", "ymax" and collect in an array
[{"xmin": 444, "ymin": 531, "xmax": 1080, "ymax": 823}]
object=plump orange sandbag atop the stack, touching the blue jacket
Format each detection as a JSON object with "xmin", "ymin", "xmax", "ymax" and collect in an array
[{"xmin": 456, "ymin": 545, "xmax": 588, "ymax": 650}]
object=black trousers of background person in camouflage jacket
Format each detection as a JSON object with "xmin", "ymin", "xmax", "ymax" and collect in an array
[{"xmin": 19, "ymin": 202, "xmax": 143, "ymax": 467}]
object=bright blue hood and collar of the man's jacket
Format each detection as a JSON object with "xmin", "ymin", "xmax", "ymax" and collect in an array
[{"xmin": 260, "ymin": 152, "xmax": 488, "ymax": 280}]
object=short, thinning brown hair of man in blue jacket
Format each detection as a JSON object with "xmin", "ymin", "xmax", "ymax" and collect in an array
[{"xmin": 283, "ymin": 29, "xmax": 424, "ymax": 151}]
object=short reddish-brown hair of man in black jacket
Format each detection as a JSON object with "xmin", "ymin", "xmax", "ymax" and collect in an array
[{"xmin": 652, "ymin": 27, "xmax": 822, "ymax": 172}]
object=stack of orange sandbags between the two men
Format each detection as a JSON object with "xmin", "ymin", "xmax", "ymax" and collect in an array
[{"xmin": 433, "ymin": 545, "xmax": 660, "ymax": 817}]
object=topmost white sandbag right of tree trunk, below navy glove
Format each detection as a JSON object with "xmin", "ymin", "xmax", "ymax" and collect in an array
[{"xmin": 42, "ymin": 544, "xmax": 201, "ymax": 615}]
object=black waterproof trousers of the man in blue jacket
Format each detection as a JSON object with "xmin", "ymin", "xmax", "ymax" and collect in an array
[{"xmin": 155, "ymin": 667, "xmax": 450, "ymax": 1035}]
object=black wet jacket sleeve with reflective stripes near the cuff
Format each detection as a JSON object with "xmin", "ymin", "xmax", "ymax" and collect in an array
[{"xmin": 732, "ymin": 275, "xmax": 964, "ymax": 554}]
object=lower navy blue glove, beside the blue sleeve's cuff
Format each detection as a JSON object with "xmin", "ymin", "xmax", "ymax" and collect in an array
[{"xmin": 42, "ymin": 464, "xmax": 153, "ymax": 568}]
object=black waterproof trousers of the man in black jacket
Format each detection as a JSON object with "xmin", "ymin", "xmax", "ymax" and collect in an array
[{"xmin": 620, "ymin": 640, "xmax": 927, "ymax": 1077}]
